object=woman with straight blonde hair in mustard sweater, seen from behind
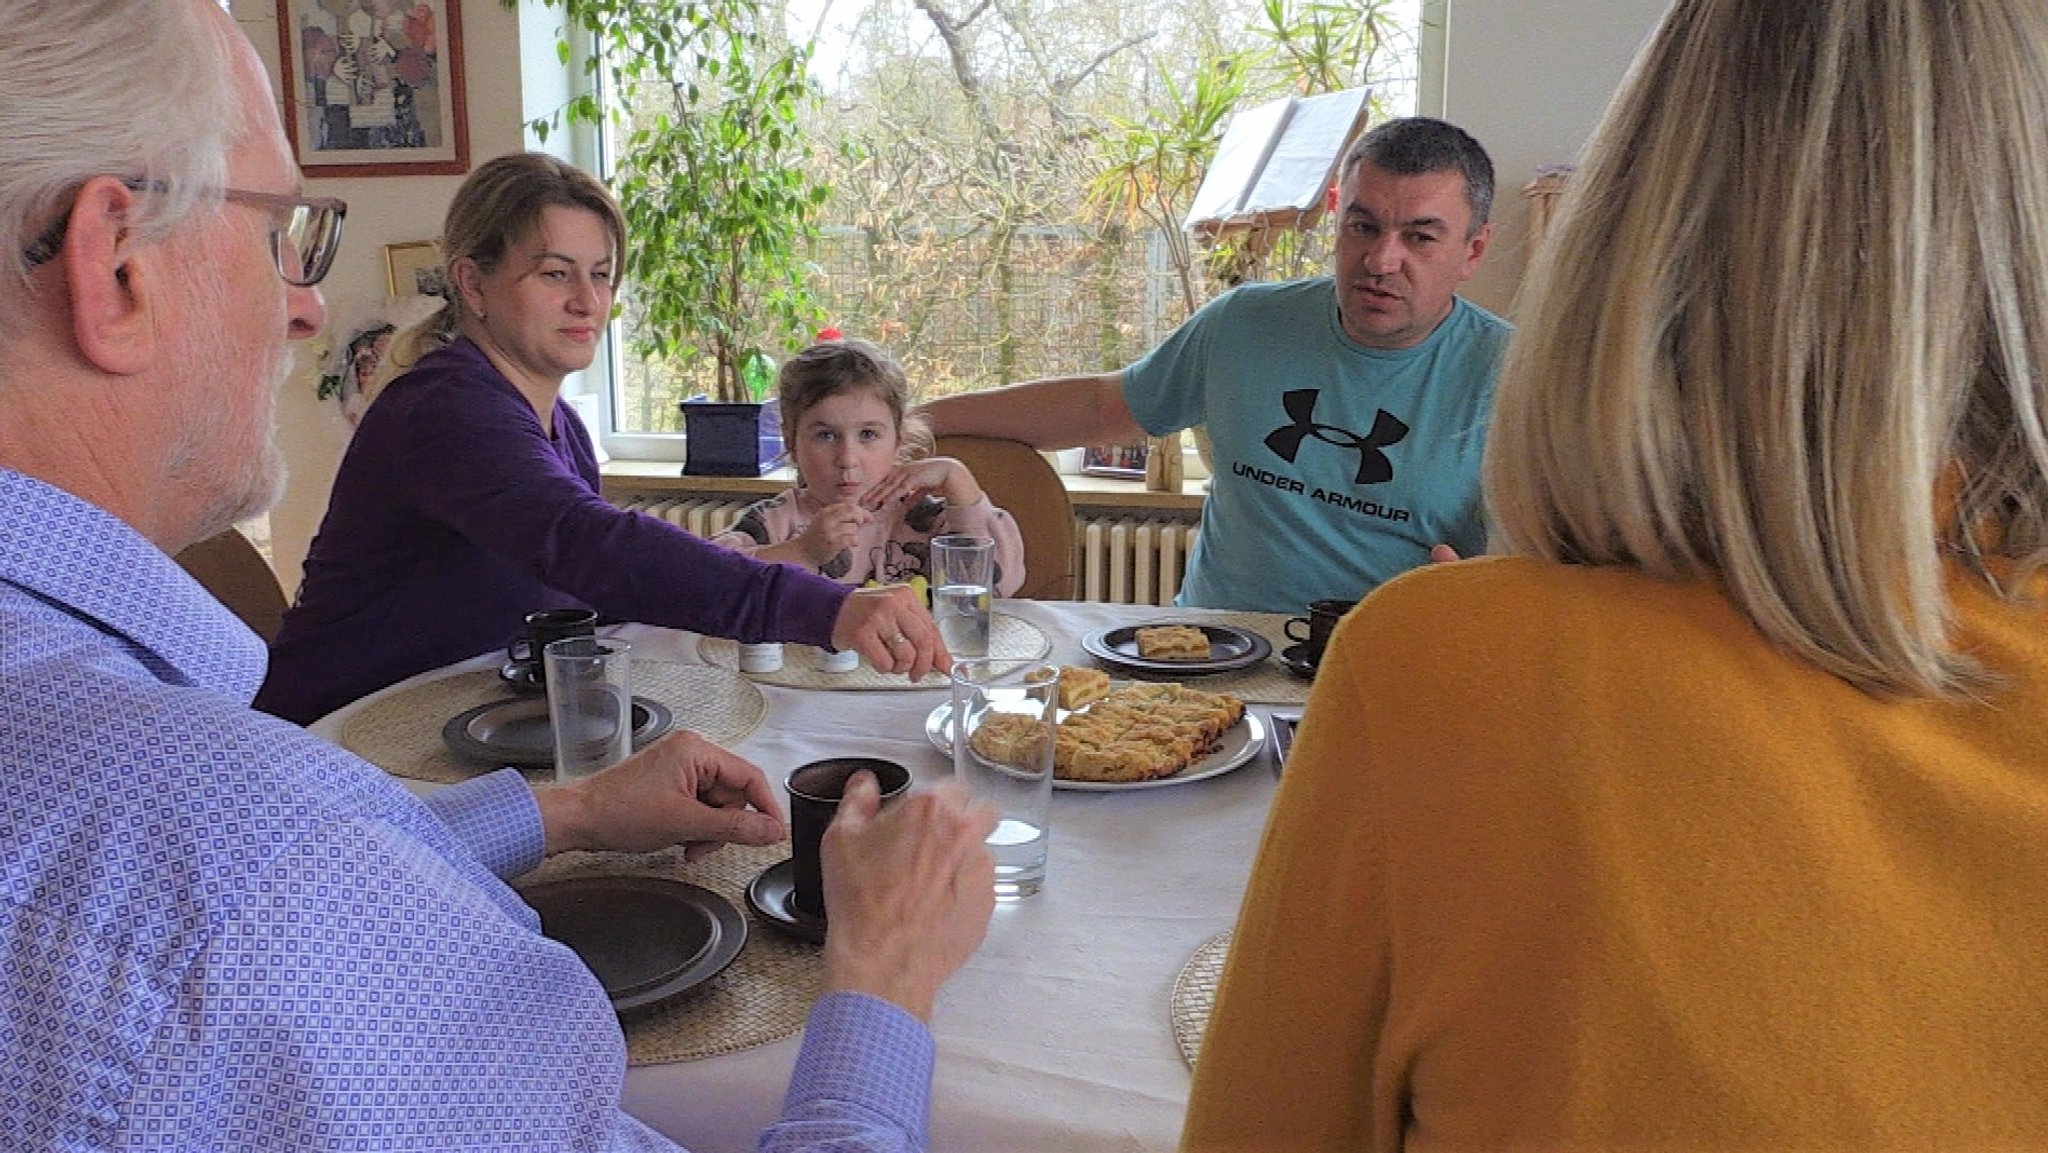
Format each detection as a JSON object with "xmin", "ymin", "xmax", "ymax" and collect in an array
[{"xmin": 1184, "ymin": 0, "xmax": 2048, "ymax": 1151}]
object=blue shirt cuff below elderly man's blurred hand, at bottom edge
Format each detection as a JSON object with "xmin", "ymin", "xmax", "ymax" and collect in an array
[{"xmin": 762, "ymin": 993, "xmax": 936, "ymax": 1149}]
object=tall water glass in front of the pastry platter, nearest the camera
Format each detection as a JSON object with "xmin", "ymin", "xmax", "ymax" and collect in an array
[{"xmin": 952, "ymin": 657, "xmax": 1059, "ymax": 901}]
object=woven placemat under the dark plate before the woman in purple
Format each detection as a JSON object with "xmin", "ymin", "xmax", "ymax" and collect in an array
[{"xmin": 342, "ymin": 661, "xmax": 768, "ymax": 784}]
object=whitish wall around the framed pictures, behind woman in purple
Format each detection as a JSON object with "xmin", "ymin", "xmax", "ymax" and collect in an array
[{"xmin": 231, "ymin": 0, "xmax": 532, "ymax": 590}]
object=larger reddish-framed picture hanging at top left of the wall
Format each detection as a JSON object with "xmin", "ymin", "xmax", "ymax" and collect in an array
[{"xmin": 276, "ymin": 0, "xmax": 469, "ymax": 176}]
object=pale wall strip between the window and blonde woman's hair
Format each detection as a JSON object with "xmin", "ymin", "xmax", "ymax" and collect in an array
[{"xmin": 1440, "ymin": 0, "xmax": 1669, "ymax": 315}]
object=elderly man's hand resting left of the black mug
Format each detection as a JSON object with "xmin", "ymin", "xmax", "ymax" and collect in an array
[{"xmin": 535, "ymin": 731, "xmax": 788, "ymax": 860}]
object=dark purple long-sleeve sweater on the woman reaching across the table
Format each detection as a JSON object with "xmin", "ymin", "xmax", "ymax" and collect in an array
[{"xmin": 256, "ymin": 340, "xmax": 850, "ymax": 723}]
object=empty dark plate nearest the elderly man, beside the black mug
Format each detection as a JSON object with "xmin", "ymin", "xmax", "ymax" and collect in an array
[{"xmin": 520, "ymin": 877, "xmax": 748, "ymax": 1014}]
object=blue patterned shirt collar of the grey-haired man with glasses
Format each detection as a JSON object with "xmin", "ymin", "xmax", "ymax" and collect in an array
[{"xmin": 0, "ymin": 469, "xmax": 268, "ymax": 702}]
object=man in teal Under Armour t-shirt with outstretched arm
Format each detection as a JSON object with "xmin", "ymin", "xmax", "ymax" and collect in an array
[{"xmin": 924, "ymin": 119, "xmax": 1509, "ymax": 612}]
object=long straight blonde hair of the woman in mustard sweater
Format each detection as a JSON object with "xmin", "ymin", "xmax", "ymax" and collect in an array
[{"xmin": 1485, "ymin": 0, "xmax": 2048, "ymax": 696}]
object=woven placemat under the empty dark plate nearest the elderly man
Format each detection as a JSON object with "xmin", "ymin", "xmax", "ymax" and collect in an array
[{"xmin": 518, "ymin": 842, "xmax": 825, "ymax": 1065}]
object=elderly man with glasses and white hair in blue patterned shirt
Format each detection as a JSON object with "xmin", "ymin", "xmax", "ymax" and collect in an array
[{"xmin": 0, "ymin": 0, "xmax": 993, "ymax": 1149}]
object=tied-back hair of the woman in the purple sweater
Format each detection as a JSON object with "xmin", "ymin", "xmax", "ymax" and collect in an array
[{"xmin": 385, "ymin": 152, "xmax": 627, "ymax": 370}]
